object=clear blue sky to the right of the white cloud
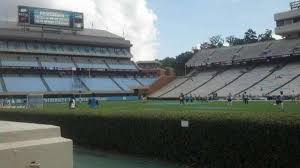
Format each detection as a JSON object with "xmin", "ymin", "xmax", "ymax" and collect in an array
[{"xmin": 148, "ymin": 0, "xmax": 290, "ymax": 59}]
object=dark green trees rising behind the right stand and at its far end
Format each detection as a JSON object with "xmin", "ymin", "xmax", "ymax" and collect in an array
[{"xmin": 156, "ymin": 29, "xmax": 275, "ymax": 75}]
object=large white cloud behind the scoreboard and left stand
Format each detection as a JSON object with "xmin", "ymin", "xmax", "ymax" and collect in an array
[{"xmin": 0, "ymin": 0, "xmax": 158, "ymax": 60}]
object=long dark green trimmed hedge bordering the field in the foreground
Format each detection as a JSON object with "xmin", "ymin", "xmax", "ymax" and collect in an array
[{"xmin": 0, "ymin": 112, "xmax": 300, "ymax": 168}]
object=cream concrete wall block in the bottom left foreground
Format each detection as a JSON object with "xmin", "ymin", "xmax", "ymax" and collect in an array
[{"xmin": 0, "ymin": 121, "xmax": 73, "ymax": 168}]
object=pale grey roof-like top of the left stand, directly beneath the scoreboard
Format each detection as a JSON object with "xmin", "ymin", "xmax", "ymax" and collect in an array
[{"xmin": 0, "ymin": 21, "xmax": 132, "ymax": 47}]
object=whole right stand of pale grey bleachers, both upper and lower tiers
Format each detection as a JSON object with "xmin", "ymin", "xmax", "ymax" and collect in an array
[{"xmin": 150, "ymin": 39, "xmax": 300, "ymax": 98}]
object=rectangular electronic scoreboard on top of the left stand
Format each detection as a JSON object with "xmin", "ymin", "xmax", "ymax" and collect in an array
[{"xmin": 18, "ymin": 6, "xmax": 84, "ymax": 30}]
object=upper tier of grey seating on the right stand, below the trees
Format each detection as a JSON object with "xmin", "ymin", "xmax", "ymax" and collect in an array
[{"xmin": 186, "ymin": 39, "xmax": 300, "ymax": 67}]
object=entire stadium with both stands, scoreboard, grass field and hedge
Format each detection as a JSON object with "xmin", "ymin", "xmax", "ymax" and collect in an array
[{"xmin": 0, "ymin": 1, "xmax": 300, "ymax": 168}]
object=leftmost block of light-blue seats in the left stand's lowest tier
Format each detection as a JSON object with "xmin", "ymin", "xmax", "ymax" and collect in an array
[{"xmin": 3, "ymin": 75, "xmax": 47, "ymax": 92}]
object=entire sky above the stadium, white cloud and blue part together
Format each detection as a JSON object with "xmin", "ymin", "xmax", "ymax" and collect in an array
[{"xmin": 0, "ymin": 0, "xmax": 291, "ymax": 61}]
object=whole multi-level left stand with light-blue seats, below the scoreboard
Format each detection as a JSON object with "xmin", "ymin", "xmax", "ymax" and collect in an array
[{"xmin": 0, "ymin": 22, "xmax": 157, "ymax": 97}]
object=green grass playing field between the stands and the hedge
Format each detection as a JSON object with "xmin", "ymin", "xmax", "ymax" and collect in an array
[{"xmin": 2, "ymin": 101, "xmax": 300, "ymax": 122}]
